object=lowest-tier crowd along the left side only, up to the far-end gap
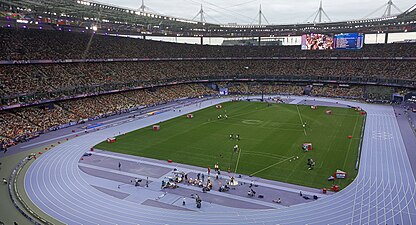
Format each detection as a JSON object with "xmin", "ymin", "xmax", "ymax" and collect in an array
[{"xmin": 0, "ymin": 84, "xmax": 217, "ymax": 147}]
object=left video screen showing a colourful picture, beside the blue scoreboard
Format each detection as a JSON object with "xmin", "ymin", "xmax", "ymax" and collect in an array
[{"xmin": 302, "ymin": 34, "xmax": 335, "ymax": 50}]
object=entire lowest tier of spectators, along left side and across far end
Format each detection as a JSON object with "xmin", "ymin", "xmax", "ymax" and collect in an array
[{"xmin": 0, "ymin": 82, "xmax": 410, "ymax": 149}]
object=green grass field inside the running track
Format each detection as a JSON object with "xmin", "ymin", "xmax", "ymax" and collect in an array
[{"xmin": 95, "ymin": 102, "xmax": 364, "ymax": 188}]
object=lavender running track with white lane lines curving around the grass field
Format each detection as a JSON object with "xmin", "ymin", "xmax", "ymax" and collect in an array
[{"xmin": 25, "ymin": 97, "xmax": 416, "ymax": 224}]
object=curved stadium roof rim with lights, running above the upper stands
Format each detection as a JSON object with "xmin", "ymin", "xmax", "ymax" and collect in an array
[{"xmin": 0, "ymin": 0, "xmax": 416, "ymax": 37}]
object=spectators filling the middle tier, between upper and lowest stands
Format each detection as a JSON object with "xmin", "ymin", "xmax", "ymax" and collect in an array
[{"xmin": 0, "ymin": 60, "xmax": 416, "ymax": 102}]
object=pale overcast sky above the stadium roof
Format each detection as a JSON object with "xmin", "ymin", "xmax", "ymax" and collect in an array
[{"xmin": 95, "ymin": 0, "xmax": 416, "ymax": 24}]
